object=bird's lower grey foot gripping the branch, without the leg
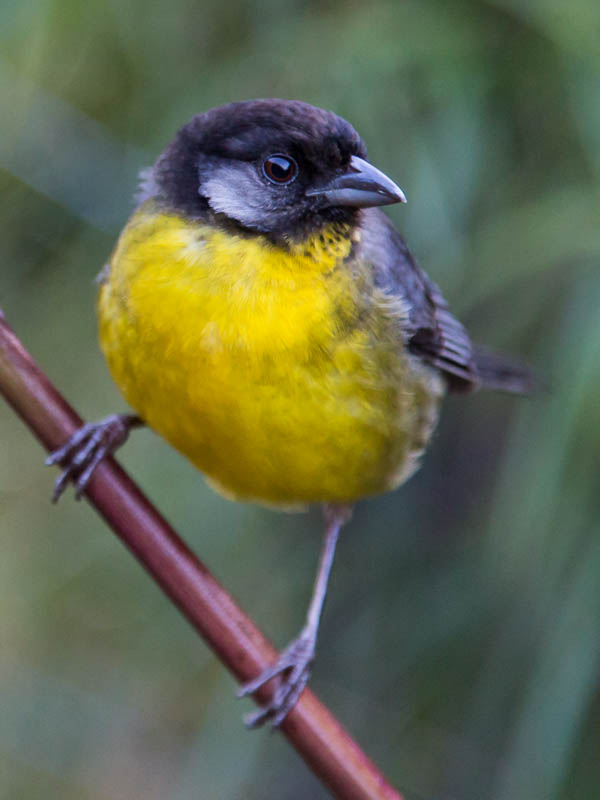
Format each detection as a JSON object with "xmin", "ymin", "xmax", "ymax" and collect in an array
[{"xmin": 238, "ymin": 629, "xmax": 316, "ymax": 728}]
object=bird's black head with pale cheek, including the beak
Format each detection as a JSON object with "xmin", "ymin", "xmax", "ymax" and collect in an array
[{"xmin": 143, "ymin": 100, "xmax": 404, "ymax": 238}]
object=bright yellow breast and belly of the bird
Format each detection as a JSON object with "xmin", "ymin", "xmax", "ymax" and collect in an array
[{"xmin": 99, "ymin": 204, "xmax": 442, "ymax": 507}]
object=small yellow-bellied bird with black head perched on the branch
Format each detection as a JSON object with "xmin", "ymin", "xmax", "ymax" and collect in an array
[{"xmin": 47, "ymin": 99, "xmax": 533, "ymax": 727}]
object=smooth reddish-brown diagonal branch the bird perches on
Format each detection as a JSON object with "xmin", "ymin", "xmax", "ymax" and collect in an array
[{"xmin": 0, "ymin": 311, "xmax": 402, "ymax": 800}]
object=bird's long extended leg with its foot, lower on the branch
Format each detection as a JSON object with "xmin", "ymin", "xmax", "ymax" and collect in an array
[{"xmin": 238, "ymin": 505, "xmax": 352, "ymax": 728}]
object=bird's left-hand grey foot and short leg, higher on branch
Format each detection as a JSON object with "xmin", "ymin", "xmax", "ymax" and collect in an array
[{"xmin": 46, "ymin": 414, "xmax": 144, "ymax": 503}]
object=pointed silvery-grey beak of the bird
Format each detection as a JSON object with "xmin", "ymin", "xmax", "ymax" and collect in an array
[{"xmin": 306, "ymin": 156, "xmax": 406, "ymax": 208}]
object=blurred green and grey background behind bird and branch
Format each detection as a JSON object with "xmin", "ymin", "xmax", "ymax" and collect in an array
[{"xmin": 0, "ymin": 0, "xmax": 600, "ymax": 800}]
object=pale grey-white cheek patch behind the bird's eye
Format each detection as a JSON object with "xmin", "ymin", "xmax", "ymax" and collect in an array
[{"xmin": 198, "ymin": 162, "xmax": 278, "ymax": 228}]
